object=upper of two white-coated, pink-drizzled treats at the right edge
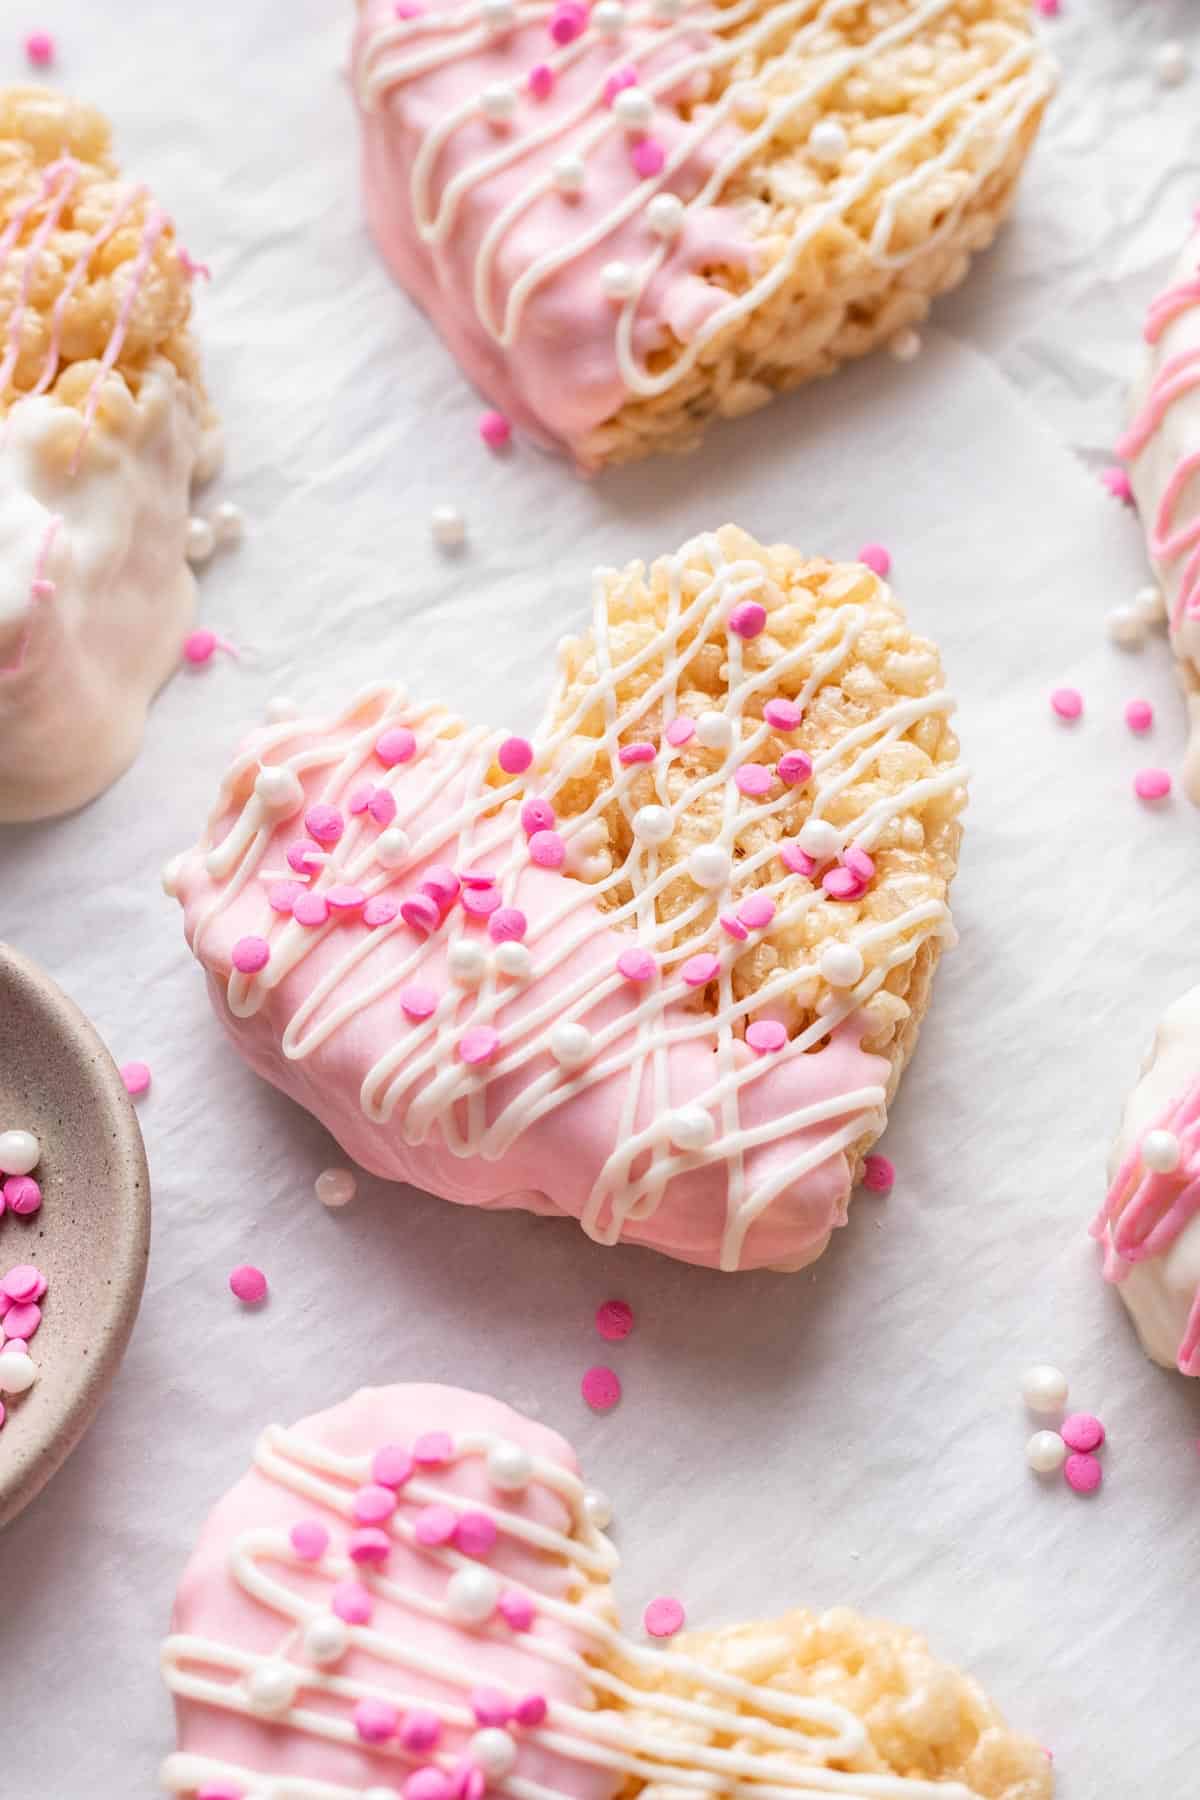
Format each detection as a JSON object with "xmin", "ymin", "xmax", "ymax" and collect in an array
[{"xmin": 1117, "ymin": 232, "xmax": 1200, "ymax": 803}]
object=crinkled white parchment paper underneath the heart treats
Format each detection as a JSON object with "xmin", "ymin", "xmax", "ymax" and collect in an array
[{"xmin": 0, "ymin": 0, "xmax": 1200, "ymax": 1800}]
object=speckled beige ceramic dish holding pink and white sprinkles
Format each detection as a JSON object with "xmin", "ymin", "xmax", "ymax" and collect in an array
[{"xmin": 0, "ymin": 943, "xmax": 149, "ymax": 1526}]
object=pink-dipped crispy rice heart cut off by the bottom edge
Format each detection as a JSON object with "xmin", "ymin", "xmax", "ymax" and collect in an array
[{"xmin": 162, "ymin": 1386, "xmax": 1054, "ymax": 1800}]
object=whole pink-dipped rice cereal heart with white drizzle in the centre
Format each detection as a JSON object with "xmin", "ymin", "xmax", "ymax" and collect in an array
[{"xmin": 166, "ymin": 526, "xmax": 966, "ymax": 1269}]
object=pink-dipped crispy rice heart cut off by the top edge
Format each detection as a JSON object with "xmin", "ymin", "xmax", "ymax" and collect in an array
[{"xmin": 353, "ymin": 0, "xmax": 1052, "ymax": 470}]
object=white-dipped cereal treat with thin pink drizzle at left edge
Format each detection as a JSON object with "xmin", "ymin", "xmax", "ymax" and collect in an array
[{"xmin": 0, "ymin": 88, "xmax": 219, "ymax": 821}]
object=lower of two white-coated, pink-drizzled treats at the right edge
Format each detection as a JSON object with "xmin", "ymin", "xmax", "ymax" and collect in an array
[{"xmin": 1092, "ymin": 988, "xmax": 1200, "ymax": 1375}]
